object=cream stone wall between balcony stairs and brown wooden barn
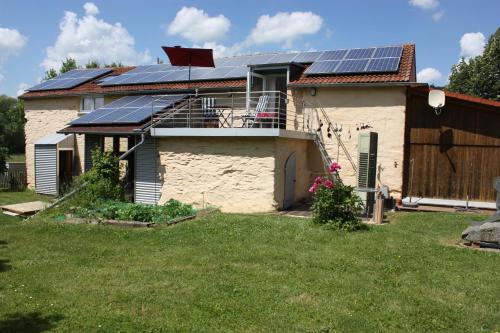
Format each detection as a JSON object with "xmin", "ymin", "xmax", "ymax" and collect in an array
[{"xmin": 292, "ymin": 87, "xmax": 406, "ymax": 197}]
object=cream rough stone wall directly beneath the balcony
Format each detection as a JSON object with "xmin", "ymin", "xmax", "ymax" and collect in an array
[{"xmin": 158, "ymin": 137, "xmax": 277, "ymax": 213}]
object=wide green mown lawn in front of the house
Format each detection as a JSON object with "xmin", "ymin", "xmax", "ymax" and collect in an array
[{"xmin": 0, "ymin": 193, "xmax": 500, "ymax": 332}]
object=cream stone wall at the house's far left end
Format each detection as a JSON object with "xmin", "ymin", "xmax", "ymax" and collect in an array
[{"xmin": 24, "ymin": 97, "xmax": 80, "ymax": 188}]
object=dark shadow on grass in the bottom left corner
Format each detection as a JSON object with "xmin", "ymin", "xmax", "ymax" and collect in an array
[{"xmin": 0, "ymin": 312, "xmax": 64, "ymax": 333}]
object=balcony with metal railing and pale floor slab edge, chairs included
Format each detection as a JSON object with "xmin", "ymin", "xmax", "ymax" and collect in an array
[{"xmin": 146, "ymin": 91, "xmax": 312, "ymax": 139}]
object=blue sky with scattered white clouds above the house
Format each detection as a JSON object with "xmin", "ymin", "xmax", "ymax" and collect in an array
[{"xmin": 0, "ymin": 0, "xmax": 500, "ymax": 96}]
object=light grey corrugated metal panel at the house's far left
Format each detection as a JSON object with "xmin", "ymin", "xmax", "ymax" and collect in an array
[{"xmin": 35, "ymin": 145, "xmax": 58, "ymax": 195}]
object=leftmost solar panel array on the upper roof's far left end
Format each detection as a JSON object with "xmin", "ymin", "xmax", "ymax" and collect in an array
[{"xmin": 28, "ymin": 68, "xmax": 112, "ymax": 91}]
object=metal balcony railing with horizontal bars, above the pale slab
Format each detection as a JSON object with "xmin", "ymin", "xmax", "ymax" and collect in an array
[{"xmin": 151, "ymin": 91, "xmax": 310, "ymax": 132}]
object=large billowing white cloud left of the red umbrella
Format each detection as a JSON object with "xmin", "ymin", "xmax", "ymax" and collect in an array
[{"xmin": 41, "ymin": 3, "xmax": 151, "ymax": 70}]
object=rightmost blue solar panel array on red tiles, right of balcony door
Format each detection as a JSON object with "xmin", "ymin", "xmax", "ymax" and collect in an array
[{"xmin": 304, "ymin": 46, "xmax": 403, "ymax": 75}]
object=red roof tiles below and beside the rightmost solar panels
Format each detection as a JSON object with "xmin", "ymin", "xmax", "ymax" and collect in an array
[{"xmin": 290, "ymin": 44, "xmax": 416, "ymax": 86}]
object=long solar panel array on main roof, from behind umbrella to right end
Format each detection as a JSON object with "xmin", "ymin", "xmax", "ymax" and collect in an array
[{"xmin": 101, "ymin": 46, "xmax": 403, "ymax": 86}]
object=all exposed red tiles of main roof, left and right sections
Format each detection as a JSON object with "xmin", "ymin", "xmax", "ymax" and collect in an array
[{"xmin": 20, "ymin": 44, "xmax": 416, "ymax": 99}]
